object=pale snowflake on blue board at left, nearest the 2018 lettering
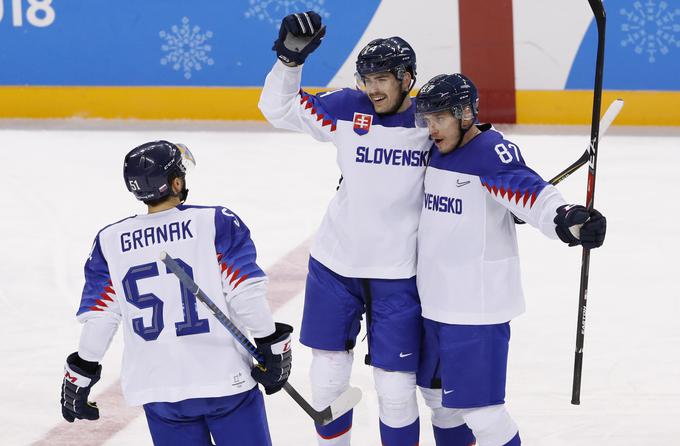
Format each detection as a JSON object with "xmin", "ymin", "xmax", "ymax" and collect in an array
[{"xmin": 158, "ymin": 17, "xmax": 215, "ymax": 79}]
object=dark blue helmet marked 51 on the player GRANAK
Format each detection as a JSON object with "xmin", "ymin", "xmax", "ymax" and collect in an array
[{"xmin": 123, "ymin": 141, "xmax": 196, "ymax": 202}]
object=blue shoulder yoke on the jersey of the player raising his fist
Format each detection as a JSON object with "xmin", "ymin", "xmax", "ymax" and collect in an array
[{"xmin": 300, "ymin": 88, "xmax": 416, "ymax": 131}]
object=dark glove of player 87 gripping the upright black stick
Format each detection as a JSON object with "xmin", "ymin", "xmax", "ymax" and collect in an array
[{"xmin": 553, "ymin": 204, "xmax": 607, "ymax": 249}]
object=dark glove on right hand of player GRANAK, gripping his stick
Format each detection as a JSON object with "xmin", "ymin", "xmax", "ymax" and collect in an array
[{"xmin": 250, "ymin": 322, "xmax": 293, "ymax": 395}]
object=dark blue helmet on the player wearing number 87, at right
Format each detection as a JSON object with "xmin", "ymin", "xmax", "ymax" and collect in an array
[{"xmin": 416, "ymin": 73, "xmax": 479, "ymax": 127}]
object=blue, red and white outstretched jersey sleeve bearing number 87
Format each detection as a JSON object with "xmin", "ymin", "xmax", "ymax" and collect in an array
[{"xmin": 480, "ymin": 138, "xmax": 565, "ymax": 238}]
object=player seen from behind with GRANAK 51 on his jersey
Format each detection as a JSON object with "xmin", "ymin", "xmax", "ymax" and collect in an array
[{"xmin": 61, "ymin": 141, "xmax": 292, "ymax": 446}]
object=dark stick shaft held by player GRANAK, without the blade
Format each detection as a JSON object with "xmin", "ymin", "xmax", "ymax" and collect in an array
[{"xmin": 161, "ymin": 252, "xmax": 350, "ymax": 425}]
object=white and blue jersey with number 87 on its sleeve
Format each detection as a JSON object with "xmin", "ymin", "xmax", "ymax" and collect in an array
[{"xmin": 417, "ymin": 124, "xmax": 564, "ymax": 325}]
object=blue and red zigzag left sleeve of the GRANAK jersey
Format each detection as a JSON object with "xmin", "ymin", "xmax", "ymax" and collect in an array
[{"xmin": 76, "ymin": 234, "xmax": 121, "ymax": 321}]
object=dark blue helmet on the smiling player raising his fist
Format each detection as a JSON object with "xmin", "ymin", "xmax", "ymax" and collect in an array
[{"xmin": 355, "ymin": 36, "xmax": 416, "ymax": 87}]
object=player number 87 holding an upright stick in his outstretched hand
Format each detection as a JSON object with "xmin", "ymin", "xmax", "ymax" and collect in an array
[{"xmin": 416, "ymin": 74, "xmax": 606, "ymax": 446}]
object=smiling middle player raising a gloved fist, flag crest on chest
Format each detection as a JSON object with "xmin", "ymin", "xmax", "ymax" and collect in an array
[{"xmin": 259, "ymin": 11, "xmax": 460, "ymax": 446}]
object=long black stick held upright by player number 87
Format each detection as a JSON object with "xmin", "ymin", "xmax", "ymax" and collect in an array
[{"xmin": 571, "ymin": 0, "xmax": 607, "ymax": 405}]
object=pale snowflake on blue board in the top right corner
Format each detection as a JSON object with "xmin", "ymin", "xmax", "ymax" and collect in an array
[{"xmin": 619, "ymin": 0, "xmax": 680, "ymax": 63}]
